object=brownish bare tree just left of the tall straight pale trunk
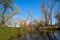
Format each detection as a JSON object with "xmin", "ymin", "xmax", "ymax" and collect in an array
[{"xmin": 41, "ymin": 3, "xmax": 49, "ymax": 26}]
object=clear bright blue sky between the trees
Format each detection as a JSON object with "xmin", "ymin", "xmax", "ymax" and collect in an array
[{"xmin": 14, "ymin": 0, "xmax": 56, "ymax": 24}]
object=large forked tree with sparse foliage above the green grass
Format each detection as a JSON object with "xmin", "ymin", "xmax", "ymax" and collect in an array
[{"xmin": 0, "ymin": 0, "xmax": 17, "ymax": 25}]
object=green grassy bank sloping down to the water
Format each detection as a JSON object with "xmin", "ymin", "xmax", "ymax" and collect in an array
[{"xmin": 0, "ymin": 27, "xmax": 23, "ymax": 40}]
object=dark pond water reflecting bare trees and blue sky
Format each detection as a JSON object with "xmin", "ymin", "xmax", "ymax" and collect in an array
[{"xmin": 10, "ymin": 30, "xmax": 60, "ymax": 40}]
